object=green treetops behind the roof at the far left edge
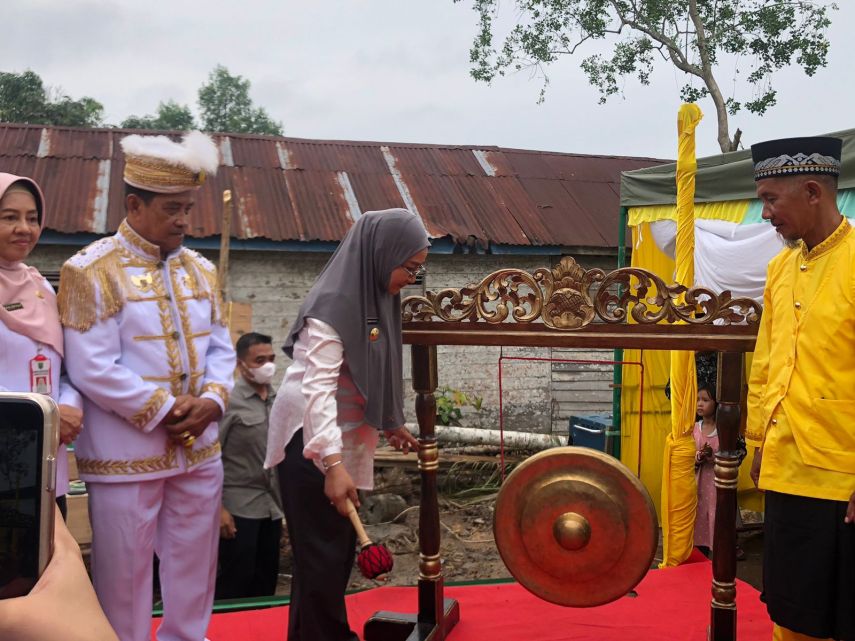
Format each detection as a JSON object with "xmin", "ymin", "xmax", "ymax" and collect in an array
[{"xmin": 0, "ymin": 70, "xmax": 104, "ymax": 127}]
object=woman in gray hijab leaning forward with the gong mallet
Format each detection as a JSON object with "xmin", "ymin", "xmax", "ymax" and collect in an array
[{"xmin": 265, "ymin": 209, "xmax": 430, "ymax": 641}]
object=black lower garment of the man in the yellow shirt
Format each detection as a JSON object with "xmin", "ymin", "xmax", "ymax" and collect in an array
[{"xmin": 761, "ymin": 492, "xmax": 855, "ymax": 641}]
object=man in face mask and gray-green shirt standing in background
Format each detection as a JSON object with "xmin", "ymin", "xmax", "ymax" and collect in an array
[{"xmin": 216, "ymin": 332, "xmax": 283, "ymax": 599}]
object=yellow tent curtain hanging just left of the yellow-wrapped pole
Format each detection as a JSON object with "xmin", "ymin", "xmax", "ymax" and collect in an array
[{"xmin": 620, "ymin": 223, "xmax": 674, "ymax": 519}]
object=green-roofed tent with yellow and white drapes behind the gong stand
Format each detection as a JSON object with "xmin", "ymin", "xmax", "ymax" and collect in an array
[{"xmin": 621, "ymin": 129, "xmax": 855, "ymax": 524}]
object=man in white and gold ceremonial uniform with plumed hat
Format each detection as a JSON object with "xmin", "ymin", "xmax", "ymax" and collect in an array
[{"xmin": 59, "ymin": 132, "xmax": 235, "ymax": 641}]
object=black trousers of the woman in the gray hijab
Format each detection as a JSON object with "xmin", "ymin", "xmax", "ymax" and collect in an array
[{"xmin": 279, "ymin": 430, "xmax": 358, "ymax": 641}]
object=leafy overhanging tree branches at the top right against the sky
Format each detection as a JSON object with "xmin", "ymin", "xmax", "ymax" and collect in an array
[{"xmin": 462, "ymin": 0, "xmax": 837, "ymax": 152}]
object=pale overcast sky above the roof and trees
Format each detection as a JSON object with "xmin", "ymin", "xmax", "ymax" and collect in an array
[{"xmin": 0, "ymin": 0, "xmax": 855, "ymax": 158}]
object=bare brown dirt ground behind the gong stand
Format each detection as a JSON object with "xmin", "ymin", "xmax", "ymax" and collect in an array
[{"xmin": 277, "ymin": 450, "xmax": 763, "ymax": 595}]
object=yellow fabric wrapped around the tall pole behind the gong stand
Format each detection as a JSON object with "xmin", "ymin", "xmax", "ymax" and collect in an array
[{"xmin": 660, "ymin": 104, "xmax": 702, "ymax": 567}]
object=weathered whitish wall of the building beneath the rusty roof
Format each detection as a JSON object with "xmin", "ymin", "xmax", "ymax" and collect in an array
[{"xmin": 28, "ymin": 245, "xmax": 615, "ymax": 432}]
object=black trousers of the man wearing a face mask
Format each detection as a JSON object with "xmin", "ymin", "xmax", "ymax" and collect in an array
[{"xmin": 215, "ymin": 516, "xmax": 282, "ymax": 599}]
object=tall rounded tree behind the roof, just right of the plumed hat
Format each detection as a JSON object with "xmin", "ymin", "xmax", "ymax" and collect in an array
[{"xmin": 199, "ymin": 65, "xmax": 282, "ymax": 136}]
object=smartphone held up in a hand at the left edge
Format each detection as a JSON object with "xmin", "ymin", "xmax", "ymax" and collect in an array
[{"xmin": 0, "ymin": 392, "xmax": 59, "ymax": 599}]
